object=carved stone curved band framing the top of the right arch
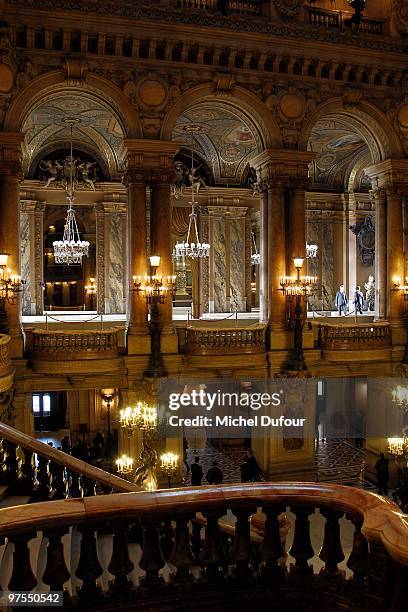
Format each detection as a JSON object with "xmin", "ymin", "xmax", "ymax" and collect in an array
[{"xmin": 299, "ymin": 97, "xmax": 403, "ymax": 163}]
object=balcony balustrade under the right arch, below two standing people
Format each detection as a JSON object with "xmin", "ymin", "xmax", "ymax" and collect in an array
[{"xmin": 318, "ymin": 322, "xmax": 391, "ymax": 351}]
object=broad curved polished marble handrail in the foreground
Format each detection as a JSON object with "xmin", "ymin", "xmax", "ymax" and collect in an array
[{"xmin": 0, "ymin": 482, "xmax": 408, "ymax": 566}]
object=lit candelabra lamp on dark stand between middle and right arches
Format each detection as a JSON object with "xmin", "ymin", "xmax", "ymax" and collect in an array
[{"xmin": 279, "ymin": 256, "xmax": 317, "ymax": 371}]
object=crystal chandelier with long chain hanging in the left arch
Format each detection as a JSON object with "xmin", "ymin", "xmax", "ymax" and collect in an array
[{"xmin": 52, "ymin": 119, "xmax": 89, "ymax": 266}]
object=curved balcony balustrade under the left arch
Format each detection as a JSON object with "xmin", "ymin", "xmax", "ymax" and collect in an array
[{"xmin": 25, "ymin": 328, "xmax": 118, "ymax": 360}]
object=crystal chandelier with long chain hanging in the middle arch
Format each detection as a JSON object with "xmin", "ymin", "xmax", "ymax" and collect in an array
[{"xmin": 173, "ymin": 125, "xmax": 210, "ymax": 261}]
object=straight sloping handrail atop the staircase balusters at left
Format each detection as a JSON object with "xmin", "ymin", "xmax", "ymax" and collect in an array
[{"xmin": 0, "ymin": 423, "xmax": 140, "ymax": 493}]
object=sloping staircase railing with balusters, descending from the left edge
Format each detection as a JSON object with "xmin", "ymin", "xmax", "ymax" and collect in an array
[{"xmin": 0, "ymin": 423, "xmax": 140, "ymax": 501}]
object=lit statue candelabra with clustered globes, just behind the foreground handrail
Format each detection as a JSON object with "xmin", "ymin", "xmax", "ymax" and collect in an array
[{"xmin": 119, "ymin": 402, "xmax": 158, "ymax": 491}]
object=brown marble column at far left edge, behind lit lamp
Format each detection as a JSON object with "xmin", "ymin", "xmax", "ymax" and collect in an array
[{"xmin": 0, "ymin": 132, "xmax": 24, "ymax": 358}]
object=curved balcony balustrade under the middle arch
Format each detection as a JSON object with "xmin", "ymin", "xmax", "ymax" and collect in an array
[{"xmin": 185, "ymin": 324, "xmax": 266, "ymax": 355}]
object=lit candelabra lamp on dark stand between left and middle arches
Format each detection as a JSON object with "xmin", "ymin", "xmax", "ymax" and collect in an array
[{"xmin": 132, "ymin": 255, "xmax": 176, "ymax": 378}]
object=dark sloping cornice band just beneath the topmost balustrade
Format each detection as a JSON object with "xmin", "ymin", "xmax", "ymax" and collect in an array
[{"xmin": 6, "ymin": 0, "xmax": 408, "ymax": 53}]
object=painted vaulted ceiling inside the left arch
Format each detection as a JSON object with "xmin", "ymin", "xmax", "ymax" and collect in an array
[{"xmin": 23, "ymin": 94, "xmax": 124, "ymax": 178}]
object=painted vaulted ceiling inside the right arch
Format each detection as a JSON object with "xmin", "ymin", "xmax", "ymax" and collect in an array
[{"xmin": 309, "ymin": 118, "xmax": 370, "ymax": 191}]
